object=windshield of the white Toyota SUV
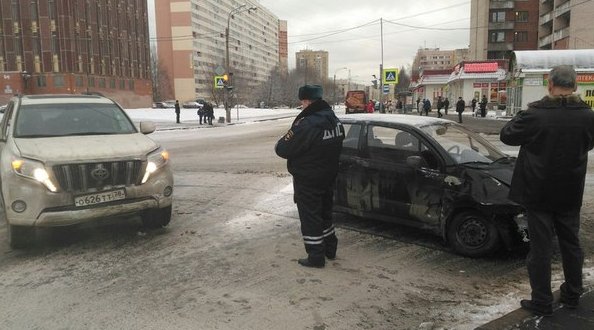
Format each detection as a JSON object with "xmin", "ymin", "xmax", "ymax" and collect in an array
[{"xmin": 14, "ymin": 103, "xmax": 136, "ymax": 138}]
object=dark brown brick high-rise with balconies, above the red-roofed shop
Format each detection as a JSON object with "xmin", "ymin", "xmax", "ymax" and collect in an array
[{"xmin": 469, "ymin": 0, "xmax": 540, "ymax": 60}]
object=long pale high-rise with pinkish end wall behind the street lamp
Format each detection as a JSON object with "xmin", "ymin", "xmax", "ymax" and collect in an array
[{"xmin": 155, "ymin": 0, "xmax": 288, "ymax": 101}]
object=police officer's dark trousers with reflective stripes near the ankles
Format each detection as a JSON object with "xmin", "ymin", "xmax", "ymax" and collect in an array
[{"xmin": 293, "ymin": 181, "xmax": 338, "ymax": 264}]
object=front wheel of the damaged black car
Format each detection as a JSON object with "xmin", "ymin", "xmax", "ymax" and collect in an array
[{"xmin": 448, "ymin": 211, "xmax": 499, "ymax": 257}]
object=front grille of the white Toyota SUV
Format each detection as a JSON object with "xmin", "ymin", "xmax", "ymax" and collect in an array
[{"xmin": 53, "ymin": 160, "xmax": 142, "ymax": 193}]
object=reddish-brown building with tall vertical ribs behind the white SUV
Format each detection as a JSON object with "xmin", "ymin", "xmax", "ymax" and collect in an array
[{"xmin": 0, "ymin": 0, "xmax": 152, "ymax": 107}]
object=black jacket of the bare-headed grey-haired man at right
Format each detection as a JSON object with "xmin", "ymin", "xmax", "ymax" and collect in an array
[{"xmin": 500, "ymin": 95, "xmax": 594, "ymax": 211}]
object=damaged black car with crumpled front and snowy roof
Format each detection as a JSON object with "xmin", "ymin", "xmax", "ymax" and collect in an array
[{"xmin": 334, "ymin": 114, "xmax": 527, "ymax": 257}]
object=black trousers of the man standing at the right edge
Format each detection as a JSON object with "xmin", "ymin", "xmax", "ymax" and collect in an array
[{"xmin": 526, "ymin": 208, "xmax": 584, "ymax": 305}]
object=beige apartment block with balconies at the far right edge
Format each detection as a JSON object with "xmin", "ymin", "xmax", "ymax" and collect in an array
[{"xmin": 538, "ymin": 0, "xmax": 594, "ymax": 49}]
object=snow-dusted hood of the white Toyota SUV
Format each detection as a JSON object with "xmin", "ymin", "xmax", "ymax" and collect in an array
[{"xmin": 15, "ymin": 133, "xmax": 158, "ymax": 162}]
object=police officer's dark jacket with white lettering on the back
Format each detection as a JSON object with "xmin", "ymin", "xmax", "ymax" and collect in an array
[{"xmin": 275, "ymin": 100, "xmax": 344, "ymax": 188}]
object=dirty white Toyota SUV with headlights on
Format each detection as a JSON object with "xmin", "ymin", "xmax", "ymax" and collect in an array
[{"xmin": 0, "ymin": 95, "xmax": 173, "ymax": 248}]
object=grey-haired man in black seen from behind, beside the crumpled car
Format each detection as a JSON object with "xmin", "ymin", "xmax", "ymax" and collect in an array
[{"xmin": 500, "ymin": 65, "xmax": 594, "ymax": 315}]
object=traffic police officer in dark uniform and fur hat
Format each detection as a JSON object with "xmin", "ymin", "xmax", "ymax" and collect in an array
[{"xmin": 275, "ymin": 85, "xmax": 344, "ymax": 268}]
